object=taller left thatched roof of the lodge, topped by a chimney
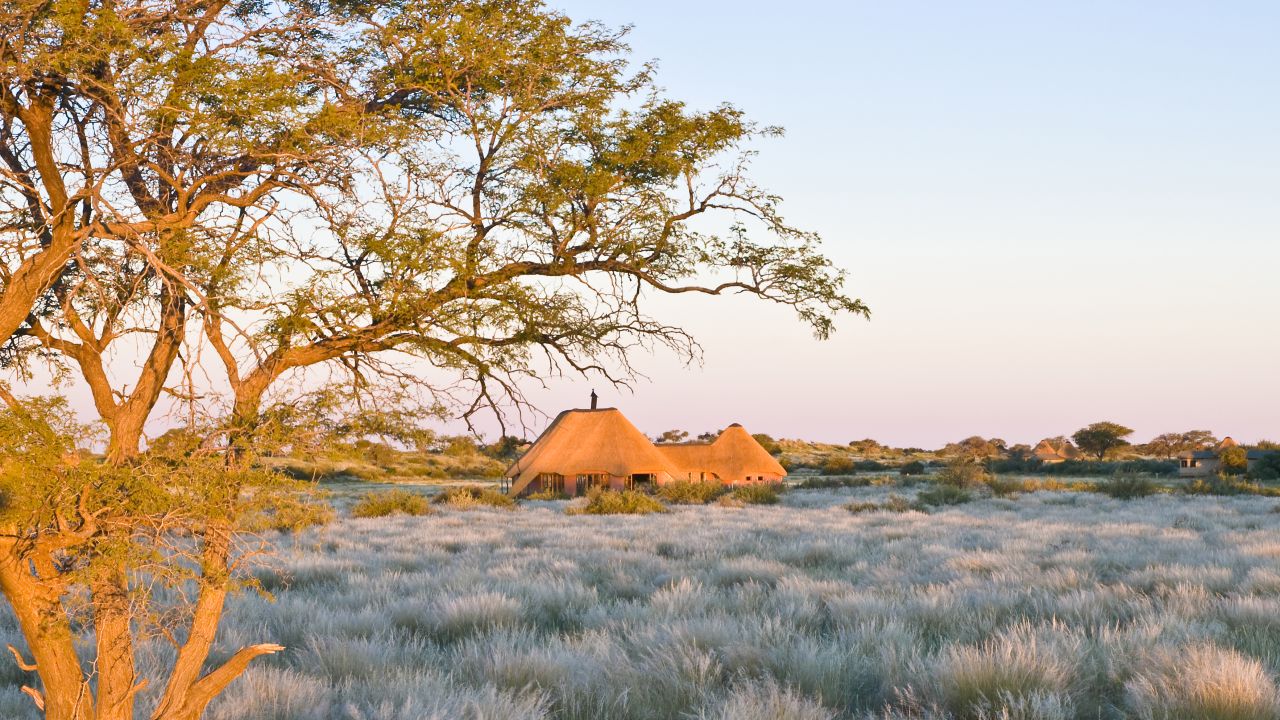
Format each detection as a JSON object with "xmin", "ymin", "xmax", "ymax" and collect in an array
[{"xmin": 507, "ymin": 407, "xmax": 672, "ymax": 495}]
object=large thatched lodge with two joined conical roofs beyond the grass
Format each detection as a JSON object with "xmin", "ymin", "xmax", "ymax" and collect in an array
[{"xmin": 506, "ymin": 407, "xmax": 787, "ymax": 497}]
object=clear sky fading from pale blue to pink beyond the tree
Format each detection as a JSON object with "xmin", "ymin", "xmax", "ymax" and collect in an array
[{"xmin": 494, "ymin": 0, "xmax": 1280, "ymax": 447}]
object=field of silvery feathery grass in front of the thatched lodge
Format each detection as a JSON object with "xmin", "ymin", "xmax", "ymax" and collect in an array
[{"xmin": 0, "ymin": 486, "xmax": 1280, "ymax": 720}]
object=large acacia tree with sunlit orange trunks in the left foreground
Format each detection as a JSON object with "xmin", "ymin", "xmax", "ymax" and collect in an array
[{"xmin": 0, "ymin": 0, "xmax": 867, "ymax": 720}]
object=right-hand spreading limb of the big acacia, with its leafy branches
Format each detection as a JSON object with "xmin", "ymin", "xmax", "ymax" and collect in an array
[{"xmin": 202, "ymin": 0, "xmax": 867, "ymax": 435}]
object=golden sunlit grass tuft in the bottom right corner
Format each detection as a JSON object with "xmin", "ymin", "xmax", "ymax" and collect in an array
[{"xmin": 1125, "ymin": 646, "xmax": 1280, "ymax": 720}]
